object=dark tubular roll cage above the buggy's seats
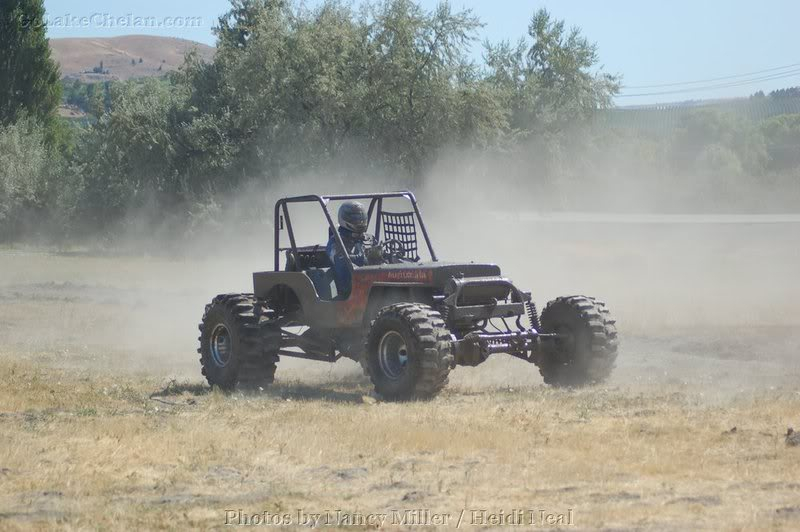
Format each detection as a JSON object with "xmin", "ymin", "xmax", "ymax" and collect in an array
[{"xmin": 275, "ymin": 191, "xmax": 438, "ymax": 272}]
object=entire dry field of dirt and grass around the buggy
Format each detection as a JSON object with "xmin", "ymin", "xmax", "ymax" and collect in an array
[{"xmin": 0, "ymin": 220, "xmax": 800, "ymax": 530}]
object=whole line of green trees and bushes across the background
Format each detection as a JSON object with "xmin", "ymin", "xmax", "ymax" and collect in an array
[{"xmin": 0, "ymin": 0, "xmax": 796, "ymax": 240}]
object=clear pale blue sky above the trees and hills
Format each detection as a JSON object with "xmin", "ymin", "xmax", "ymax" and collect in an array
[{"xmin": 45, "ymin": 0, "xmax": 800, "ymax": 105}]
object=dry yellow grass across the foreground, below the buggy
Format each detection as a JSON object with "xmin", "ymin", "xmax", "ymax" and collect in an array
[{"xmin": 0, "ymin": 353, "xmax": 800, "ymax": 530}]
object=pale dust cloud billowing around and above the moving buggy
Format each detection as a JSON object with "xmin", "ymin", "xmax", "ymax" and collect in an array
[{"xmin": 0, "ymin": 143, "xmax": 800, "ymax": 391}]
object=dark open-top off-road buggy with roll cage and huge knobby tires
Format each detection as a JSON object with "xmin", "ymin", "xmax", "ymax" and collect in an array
[{"xmin": 198, "ymin": 192, "xmax": 617, "ymax": 400}]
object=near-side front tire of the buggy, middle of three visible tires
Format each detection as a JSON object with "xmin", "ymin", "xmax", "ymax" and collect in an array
[{"xmin": 362, "ymin": 303, "xmax": 453, "ymax": 401}]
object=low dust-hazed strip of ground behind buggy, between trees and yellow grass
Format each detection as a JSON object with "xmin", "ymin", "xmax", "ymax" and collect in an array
[{"xmin": 0, "ymin": 193, "xmax": 800, "ymax": 392}]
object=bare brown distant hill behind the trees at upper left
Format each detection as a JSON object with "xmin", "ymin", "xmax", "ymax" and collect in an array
[{"xmin": 50, "ymin": 35, "xmax": 215, "ymax": 81}]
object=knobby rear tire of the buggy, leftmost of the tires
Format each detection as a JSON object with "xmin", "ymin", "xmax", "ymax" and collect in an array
[{"xmin": 197, "ymin": 294, "xmax": 281, "ymax": 391}]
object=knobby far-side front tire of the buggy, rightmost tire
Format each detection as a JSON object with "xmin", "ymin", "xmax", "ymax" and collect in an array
[{"xmin": 538, "ymin": 296, "xmax": 618, "ymax": 387}]
